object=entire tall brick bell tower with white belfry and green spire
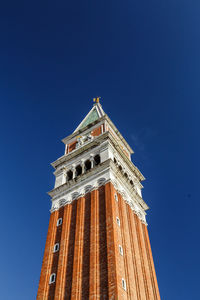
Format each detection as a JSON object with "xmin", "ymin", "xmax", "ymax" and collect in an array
[{"xmin": 37, "ymin": 98, "xmax": 160, "ymax": 300}]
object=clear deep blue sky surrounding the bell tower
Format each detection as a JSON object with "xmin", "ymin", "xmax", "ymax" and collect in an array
[{"xmin": 0, "ymin": 0, "xmax": 200, "ymax": 300}]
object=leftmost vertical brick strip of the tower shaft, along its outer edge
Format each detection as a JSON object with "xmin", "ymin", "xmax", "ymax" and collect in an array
[{"xmin": 37, "ymin": 211, "xmax": 58, "ymax": 300}]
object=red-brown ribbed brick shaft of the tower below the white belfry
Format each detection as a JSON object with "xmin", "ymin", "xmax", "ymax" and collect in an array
[{"xmin": 37, "ymin": 183, "xmax": 160, "ymax": 300}]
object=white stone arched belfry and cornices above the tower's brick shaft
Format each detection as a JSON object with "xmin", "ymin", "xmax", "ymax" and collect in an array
[{"xmin": 49, "ymin": 103, "xmax": 148, "ymax": 224}]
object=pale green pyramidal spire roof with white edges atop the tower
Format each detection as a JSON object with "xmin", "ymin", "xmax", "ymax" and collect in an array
[{"xmin": 74, "ymin": 103, "xmax": 105, "ymax": 132}]
